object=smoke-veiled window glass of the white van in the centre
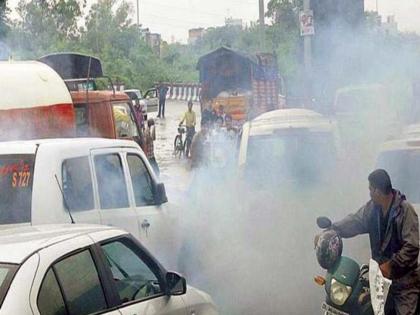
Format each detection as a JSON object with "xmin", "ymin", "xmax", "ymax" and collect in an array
[{"xmin": 245, "ymin": 130, "xmax": 336, "ymax": 187}]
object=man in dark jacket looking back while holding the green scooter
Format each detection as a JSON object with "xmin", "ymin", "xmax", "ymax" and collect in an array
[{"xmin": 333, "ymin": 169, "xmax": 420, "ymax": 315}]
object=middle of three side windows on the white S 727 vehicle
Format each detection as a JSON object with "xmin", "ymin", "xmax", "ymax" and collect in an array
[{"xmin": 95, "ymin": 154, "xmax": 129, "ymax": 209}]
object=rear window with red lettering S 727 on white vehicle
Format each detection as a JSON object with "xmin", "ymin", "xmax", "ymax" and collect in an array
[{"xmin": 0, "ymin": 154, "xmax": 35, "ymax": 224}]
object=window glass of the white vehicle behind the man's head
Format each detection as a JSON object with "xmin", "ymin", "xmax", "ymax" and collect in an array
[{"xmin": 377, "ymin": 150, "xmax": 420, "ymax": 203}]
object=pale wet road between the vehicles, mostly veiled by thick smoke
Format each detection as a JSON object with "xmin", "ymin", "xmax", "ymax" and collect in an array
[{"xmin": 149, "ymin": 101, "xmax": 368, "ymax": 315}]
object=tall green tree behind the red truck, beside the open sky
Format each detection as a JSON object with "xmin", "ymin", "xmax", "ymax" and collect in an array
[{"xmin": 80, "ymin": 0, "xmax": 171, "ymax": 89}]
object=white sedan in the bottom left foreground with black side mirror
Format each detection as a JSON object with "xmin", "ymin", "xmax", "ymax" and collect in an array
[{"xmin": 0, "ymin": 225, "xmax": 218, "ymax": 315}]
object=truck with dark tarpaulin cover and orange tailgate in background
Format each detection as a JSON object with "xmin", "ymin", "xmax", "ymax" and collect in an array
[{"xmin": 197, "ymin": 47, "xmax": 283, "ymax": 124}]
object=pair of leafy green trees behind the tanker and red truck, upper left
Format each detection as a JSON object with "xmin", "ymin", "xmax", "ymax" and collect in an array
[{"xmin": 8, "ymin": 0, "xmax": 176, "ymax": 89}]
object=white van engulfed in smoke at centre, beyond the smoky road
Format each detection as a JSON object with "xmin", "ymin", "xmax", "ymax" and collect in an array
[{"xmin": 238, "ymin": 108, "xmax": 338, "ymax": 187}]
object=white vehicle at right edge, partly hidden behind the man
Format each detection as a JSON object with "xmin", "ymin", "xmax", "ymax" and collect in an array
[{"xmin": 376, "ymin": 132, "xmax": 420, "ymax": 210}]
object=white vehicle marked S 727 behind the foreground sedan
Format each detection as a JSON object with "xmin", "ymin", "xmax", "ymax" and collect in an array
[{"xmin": 0, "ymin": 138, "xmax": 176, "ymax": 267}]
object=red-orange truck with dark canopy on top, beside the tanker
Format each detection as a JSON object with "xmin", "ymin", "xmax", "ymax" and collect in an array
[{"xmin": 39, "ymin": 53, "xmax": 142, "ymax": 144}]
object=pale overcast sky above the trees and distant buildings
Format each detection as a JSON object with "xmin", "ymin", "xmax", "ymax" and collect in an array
[{"xmin": 9, "ymin": 0, "xmax": 420, "ymax": 42}]
